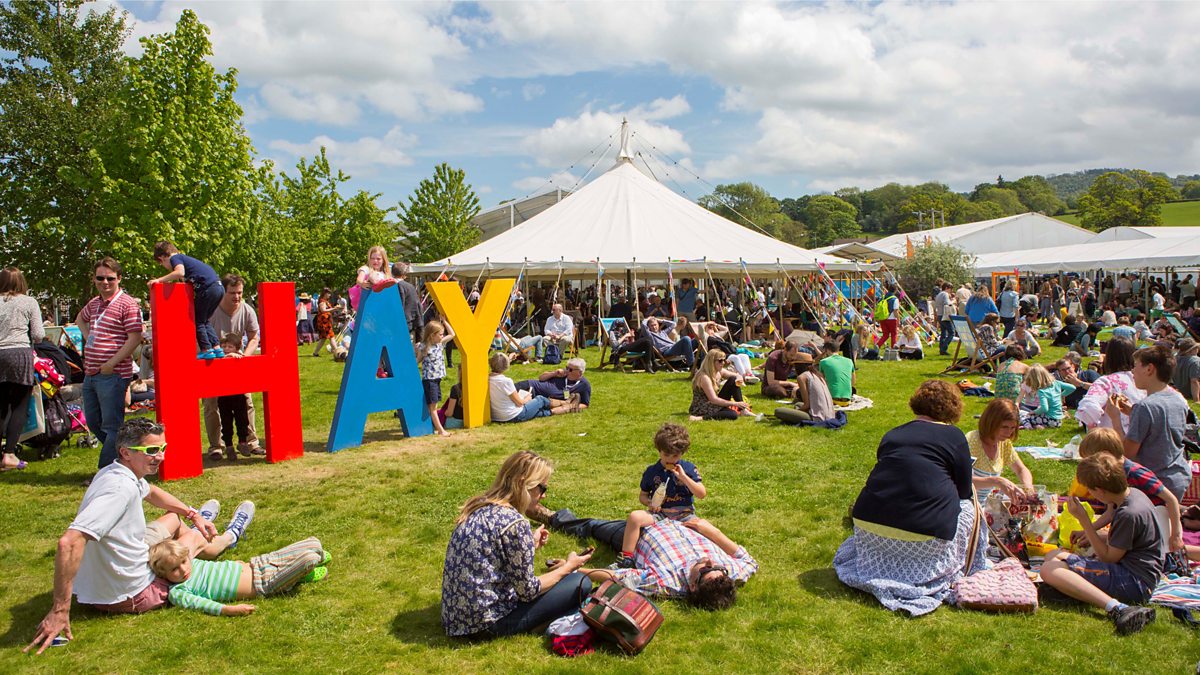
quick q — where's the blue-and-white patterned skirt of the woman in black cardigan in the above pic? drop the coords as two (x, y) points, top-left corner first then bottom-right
(833, 500), (991, 616)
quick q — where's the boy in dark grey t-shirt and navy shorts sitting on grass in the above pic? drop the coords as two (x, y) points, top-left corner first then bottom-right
(1042, 453), (1165, 634)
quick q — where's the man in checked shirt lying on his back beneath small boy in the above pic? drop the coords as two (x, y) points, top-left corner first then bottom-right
(529, 504), (758, 610)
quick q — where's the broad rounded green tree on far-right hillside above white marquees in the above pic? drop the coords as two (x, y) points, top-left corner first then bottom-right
(1079, 169), (1178, 231)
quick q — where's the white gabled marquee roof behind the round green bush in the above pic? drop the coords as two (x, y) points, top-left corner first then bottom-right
(870, 213), (1096, 258)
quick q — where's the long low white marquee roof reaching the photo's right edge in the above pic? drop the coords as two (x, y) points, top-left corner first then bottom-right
(974, 230), (1200, 276)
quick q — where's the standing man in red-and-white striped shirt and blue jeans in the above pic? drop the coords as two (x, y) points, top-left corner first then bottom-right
(76, 257), (142, 468)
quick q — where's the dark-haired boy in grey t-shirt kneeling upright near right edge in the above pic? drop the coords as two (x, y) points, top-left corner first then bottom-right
(1105, 345), (1192, 500)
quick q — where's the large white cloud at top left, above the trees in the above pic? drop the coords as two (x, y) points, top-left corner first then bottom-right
(119, 0), (482, 125)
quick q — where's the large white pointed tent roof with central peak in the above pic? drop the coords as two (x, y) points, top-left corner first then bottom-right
(414, 130), (878, 282)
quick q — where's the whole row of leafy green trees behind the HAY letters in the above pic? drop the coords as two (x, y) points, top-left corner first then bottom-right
(0, 0), (479, 299)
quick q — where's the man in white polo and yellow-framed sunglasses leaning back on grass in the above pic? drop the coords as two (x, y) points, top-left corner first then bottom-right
(25, 418), (254, 653)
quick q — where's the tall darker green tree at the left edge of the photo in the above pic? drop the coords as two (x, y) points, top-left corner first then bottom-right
(0, 0), (128, 299)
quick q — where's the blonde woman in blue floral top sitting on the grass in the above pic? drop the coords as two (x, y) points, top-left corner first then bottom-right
(442, 450), (592, 637)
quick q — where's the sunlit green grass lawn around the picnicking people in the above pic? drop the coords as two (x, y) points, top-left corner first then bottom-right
(0, 350), (1200, 674)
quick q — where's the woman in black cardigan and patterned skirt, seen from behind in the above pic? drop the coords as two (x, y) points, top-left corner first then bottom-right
(833, 380), (989, 616)
